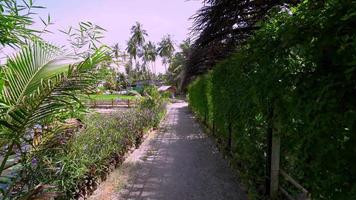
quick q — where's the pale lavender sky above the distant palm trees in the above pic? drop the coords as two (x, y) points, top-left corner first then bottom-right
(35, 0), (202, 72)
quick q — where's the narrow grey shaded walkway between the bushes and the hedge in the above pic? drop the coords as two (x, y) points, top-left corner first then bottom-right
(90, 103), (247, 200)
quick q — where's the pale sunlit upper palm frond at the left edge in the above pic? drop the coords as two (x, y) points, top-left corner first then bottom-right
(2, 42), (69, 105)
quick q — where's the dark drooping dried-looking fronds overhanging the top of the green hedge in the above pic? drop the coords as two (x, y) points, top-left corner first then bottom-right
(183, 0), (300, 85)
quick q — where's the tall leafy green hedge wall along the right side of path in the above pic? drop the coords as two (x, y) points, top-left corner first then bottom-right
(188, 0), (356, 199)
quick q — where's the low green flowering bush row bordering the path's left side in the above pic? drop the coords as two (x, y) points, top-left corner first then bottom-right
(18, 93), (168, 199)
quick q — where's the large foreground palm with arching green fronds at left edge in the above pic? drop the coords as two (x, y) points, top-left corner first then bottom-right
(0, 41), (108, 196)
